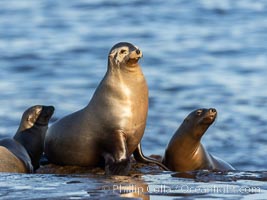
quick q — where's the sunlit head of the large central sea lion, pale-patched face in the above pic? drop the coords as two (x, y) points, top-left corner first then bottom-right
(109, 42), (143, 68)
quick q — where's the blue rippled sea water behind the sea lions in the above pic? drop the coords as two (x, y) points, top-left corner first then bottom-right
(0, 0), (267, 199)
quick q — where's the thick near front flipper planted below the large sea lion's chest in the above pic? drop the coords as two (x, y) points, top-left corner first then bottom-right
(102, 131), (130, 175)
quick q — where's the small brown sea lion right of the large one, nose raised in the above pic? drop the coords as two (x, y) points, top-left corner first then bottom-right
(162, 108), (234, 172)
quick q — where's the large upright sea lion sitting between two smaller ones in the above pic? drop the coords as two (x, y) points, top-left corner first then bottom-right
(45, 42), (168, 175)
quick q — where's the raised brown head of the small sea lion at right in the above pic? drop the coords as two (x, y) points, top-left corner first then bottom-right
(182, 108), (217, 139)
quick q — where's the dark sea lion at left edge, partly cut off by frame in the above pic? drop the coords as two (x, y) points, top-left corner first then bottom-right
(0, 105), (54, 173)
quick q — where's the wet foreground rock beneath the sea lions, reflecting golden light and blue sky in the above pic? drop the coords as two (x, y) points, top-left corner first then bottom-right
(0, 161), (267, 199)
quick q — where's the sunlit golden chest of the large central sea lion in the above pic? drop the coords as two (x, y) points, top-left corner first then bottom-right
(89, 72), (148, 152)
